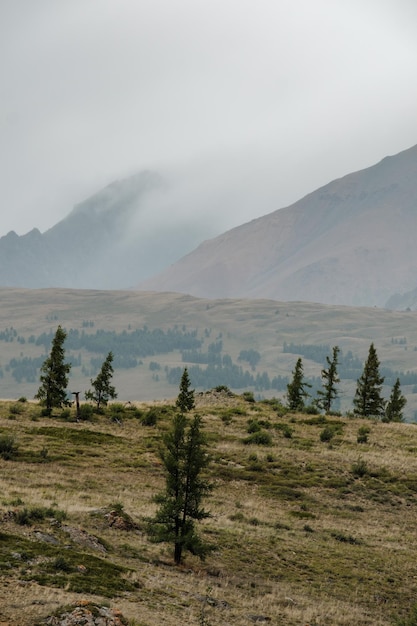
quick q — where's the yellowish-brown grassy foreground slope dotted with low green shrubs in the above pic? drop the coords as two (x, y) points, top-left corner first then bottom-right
(0, 392), (417, 626)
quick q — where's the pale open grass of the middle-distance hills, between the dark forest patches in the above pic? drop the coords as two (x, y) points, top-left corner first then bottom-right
(0, 289), (417, 421)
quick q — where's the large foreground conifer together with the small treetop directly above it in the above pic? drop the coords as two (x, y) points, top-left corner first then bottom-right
(148, 370), (212, 565)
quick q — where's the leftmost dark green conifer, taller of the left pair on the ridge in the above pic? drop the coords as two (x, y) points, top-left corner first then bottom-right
(35, 326), (71, 414)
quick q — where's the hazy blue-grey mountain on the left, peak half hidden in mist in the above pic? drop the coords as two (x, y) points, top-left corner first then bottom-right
(0, 171), (204, 289)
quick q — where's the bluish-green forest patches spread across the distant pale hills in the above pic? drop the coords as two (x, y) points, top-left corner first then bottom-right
(0, 321), (417, 392)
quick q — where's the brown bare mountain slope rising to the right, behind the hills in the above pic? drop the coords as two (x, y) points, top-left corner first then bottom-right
(139, 146), (417, 306)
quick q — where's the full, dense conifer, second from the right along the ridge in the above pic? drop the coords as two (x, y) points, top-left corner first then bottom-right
(353, 343), (385, 417)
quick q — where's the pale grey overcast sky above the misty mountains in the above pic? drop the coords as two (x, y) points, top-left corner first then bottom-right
(0, 0), (417, 235)
